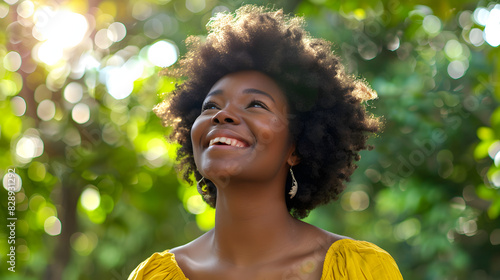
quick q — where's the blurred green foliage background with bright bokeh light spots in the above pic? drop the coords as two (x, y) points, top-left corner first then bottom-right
(0, 0), (500, 280)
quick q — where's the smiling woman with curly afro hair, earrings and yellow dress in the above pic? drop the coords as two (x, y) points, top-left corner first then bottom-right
(129, 6), (402, 280)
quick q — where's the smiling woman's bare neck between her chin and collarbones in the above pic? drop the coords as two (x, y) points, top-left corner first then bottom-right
(212, 180), (301, 265)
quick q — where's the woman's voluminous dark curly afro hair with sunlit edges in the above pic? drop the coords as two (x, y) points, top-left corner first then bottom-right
(155, 5), (380, 218)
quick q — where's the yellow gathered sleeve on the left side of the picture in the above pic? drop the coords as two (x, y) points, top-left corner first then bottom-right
(128, 250), (188, 280)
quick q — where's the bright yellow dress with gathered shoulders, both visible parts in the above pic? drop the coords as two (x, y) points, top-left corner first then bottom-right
(128, 239), (403, 280)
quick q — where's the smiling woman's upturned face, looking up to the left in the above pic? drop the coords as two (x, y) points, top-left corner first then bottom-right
(191, 71), (294, 187)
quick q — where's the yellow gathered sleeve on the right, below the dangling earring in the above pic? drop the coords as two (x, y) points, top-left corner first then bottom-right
(321, 239), (403, 280)
